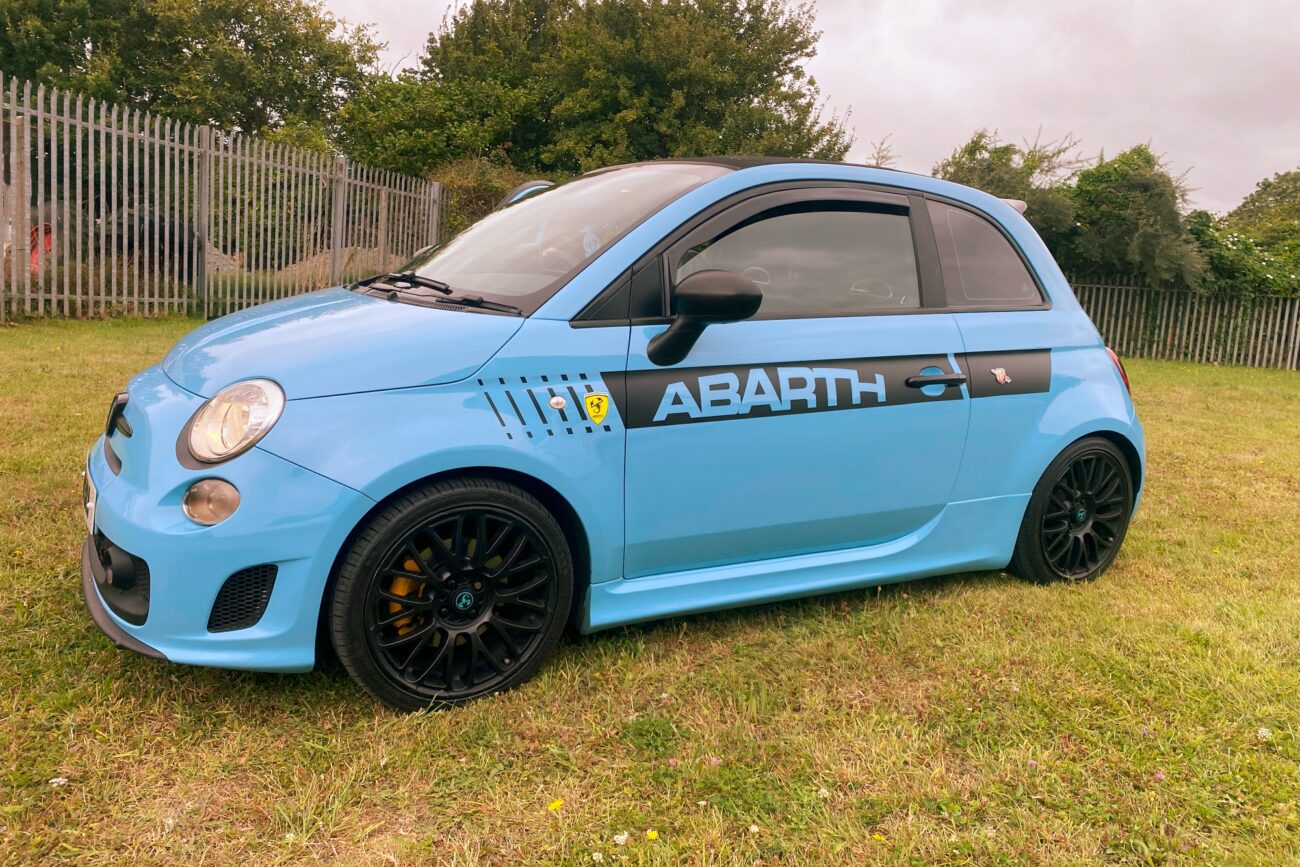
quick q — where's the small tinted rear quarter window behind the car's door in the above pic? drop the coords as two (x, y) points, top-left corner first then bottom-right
(927, 201), (1043, 307)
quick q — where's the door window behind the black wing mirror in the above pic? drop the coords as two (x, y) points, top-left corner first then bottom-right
(673, 203), (920, 316)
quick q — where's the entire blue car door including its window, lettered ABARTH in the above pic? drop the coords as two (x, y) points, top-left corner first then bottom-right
(616, 187), (969, 578)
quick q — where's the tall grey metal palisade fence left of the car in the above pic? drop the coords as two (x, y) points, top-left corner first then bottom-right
(0, 74), (442, 321)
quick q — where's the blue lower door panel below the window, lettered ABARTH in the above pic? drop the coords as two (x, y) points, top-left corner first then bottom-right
(625, 313), (970, 578)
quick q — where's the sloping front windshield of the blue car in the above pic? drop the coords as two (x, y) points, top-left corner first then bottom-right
(403, 162), (729, 312)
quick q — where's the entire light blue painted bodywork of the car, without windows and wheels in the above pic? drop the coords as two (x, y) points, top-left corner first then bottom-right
(76, 162), (1144, 671)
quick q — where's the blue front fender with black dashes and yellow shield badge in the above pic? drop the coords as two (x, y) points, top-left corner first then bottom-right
(260, 318), (628, 590)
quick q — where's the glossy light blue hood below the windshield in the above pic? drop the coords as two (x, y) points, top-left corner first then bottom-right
(163, 289), (524, 400)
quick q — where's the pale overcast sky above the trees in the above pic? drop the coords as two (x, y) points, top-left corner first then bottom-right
(326, 0), (1300, 211)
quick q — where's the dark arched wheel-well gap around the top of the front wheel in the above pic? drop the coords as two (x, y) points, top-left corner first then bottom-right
(316, 465), (592, 664)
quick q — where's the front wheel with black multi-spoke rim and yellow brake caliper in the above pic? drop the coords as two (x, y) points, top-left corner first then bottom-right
(330, 478), (573, 711)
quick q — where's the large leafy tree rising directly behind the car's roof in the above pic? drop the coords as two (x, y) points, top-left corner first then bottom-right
(343, 0), (852, 174)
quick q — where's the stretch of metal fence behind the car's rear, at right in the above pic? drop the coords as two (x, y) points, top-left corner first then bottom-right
(1074, 282), (1300, 370)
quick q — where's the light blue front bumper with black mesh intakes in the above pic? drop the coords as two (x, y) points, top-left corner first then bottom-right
(82, 368), (374, 672)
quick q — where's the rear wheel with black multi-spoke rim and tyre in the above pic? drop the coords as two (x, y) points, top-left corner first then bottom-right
(1009, 437), (1134, 584)
